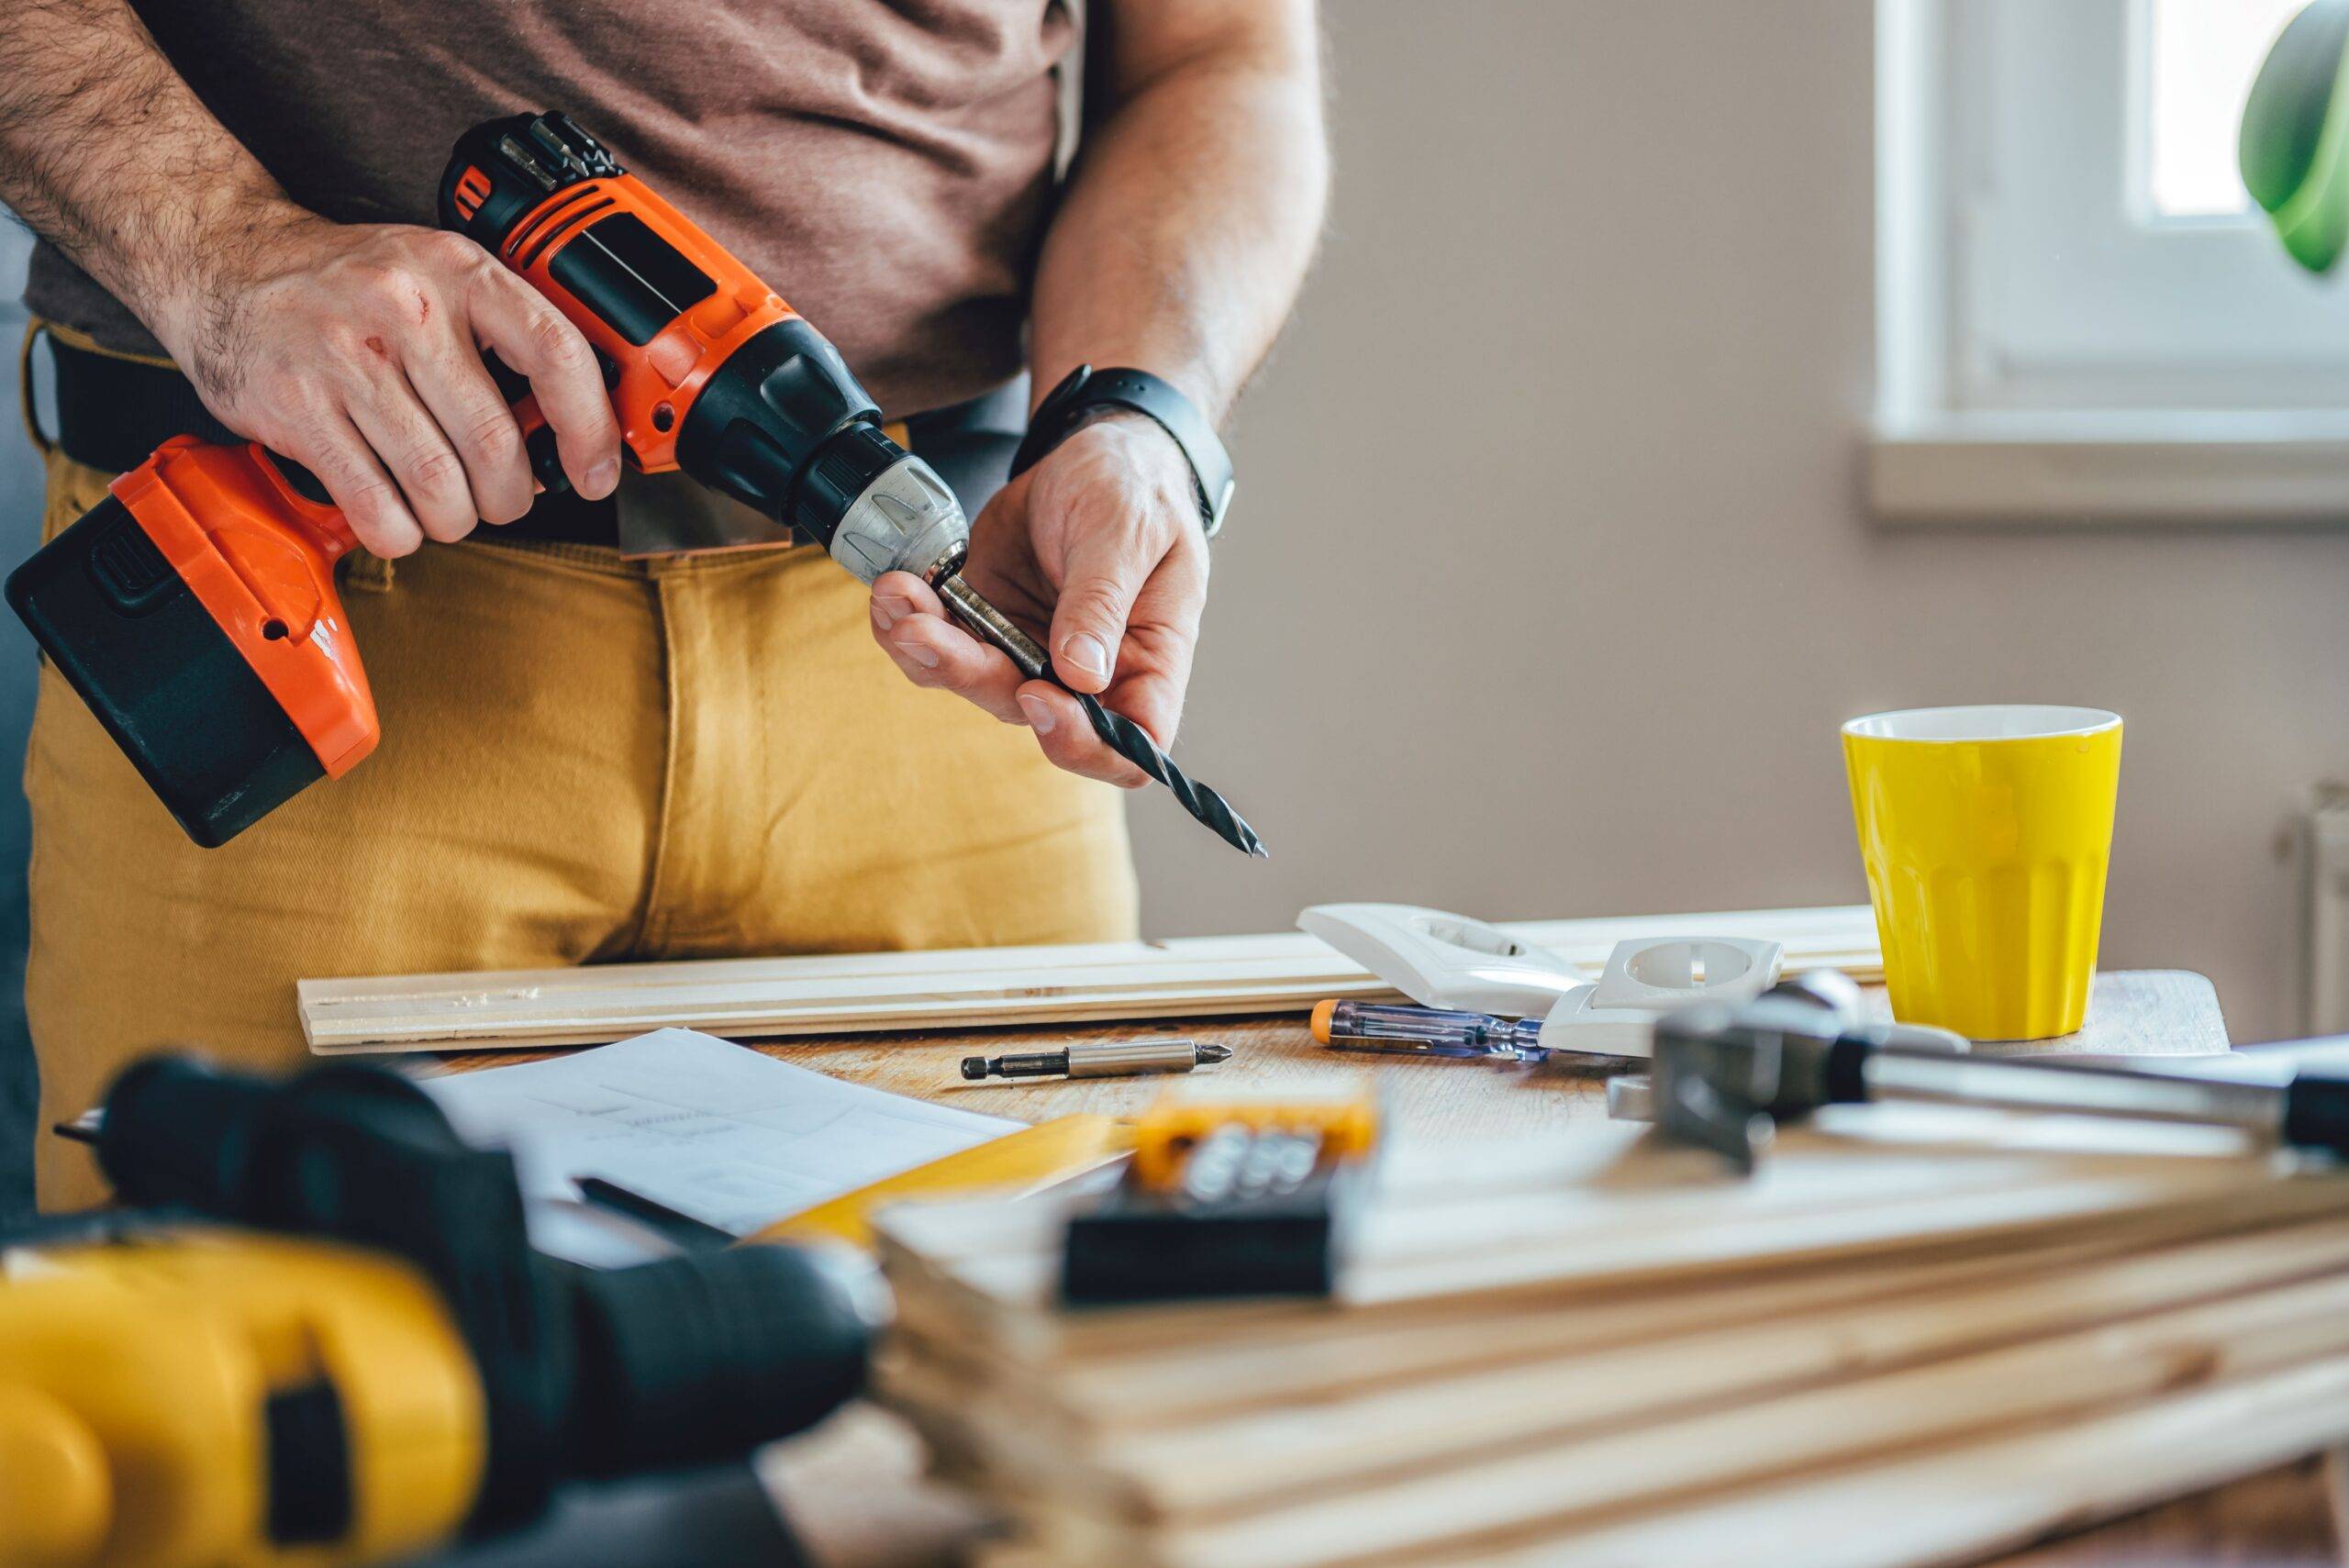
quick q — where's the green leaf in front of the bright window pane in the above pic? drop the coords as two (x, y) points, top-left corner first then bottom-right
(2236, 0), (2349, 272)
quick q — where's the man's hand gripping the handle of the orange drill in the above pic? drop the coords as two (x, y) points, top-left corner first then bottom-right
(150, 206), (620, 556)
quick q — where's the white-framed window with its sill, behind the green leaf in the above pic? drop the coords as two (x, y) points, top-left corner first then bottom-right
(1870, 0), (2349, 521)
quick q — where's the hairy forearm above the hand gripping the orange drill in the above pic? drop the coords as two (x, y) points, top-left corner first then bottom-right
(0, 0), (294, 345)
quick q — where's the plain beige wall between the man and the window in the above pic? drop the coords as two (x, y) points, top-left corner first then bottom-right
(1132, 0), (2349, 1040)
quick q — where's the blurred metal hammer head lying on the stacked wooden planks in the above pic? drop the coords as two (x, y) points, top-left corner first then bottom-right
(1649, 976), (1854, 1173)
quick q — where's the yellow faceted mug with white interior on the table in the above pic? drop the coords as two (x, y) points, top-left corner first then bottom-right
(1844, 705), (2121, 1040)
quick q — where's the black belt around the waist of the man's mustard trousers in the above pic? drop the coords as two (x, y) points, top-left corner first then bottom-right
(35, 328), (1027, 547)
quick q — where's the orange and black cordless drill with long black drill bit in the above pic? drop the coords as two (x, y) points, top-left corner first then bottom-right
(7, 113), (1262, 854)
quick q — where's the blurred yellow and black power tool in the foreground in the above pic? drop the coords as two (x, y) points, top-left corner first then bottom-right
(0, 1059), (878, 1568)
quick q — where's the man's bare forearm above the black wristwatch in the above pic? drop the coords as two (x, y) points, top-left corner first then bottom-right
(1031, 0), (1330, 420)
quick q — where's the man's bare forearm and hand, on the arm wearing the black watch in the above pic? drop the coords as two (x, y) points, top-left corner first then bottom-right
(872, 0), (1330, 789)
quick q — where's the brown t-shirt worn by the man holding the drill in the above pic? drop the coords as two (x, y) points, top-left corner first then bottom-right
(29, 0), (1075, 416)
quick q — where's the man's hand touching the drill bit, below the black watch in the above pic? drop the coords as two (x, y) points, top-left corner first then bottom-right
(872, 413), (1208, 789)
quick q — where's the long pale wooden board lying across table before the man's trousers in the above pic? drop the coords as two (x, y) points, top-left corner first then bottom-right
(296, 904), (1884, 1056)
